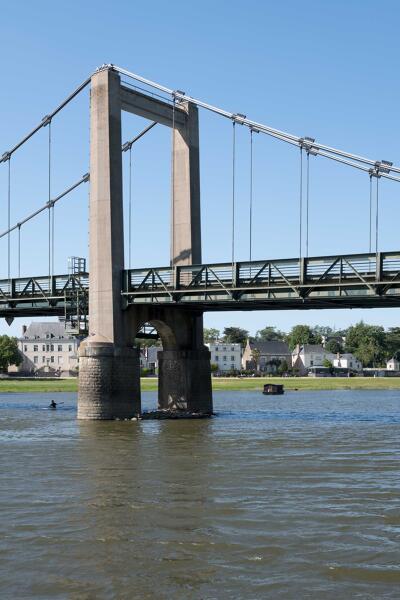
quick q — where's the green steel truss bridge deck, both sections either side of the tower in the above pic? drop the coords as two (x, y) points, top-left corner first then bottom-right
(0, 252), (400, 317)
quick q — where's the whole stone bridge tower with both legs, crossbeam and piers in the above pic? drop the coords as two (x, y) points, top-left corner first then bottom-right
(78, 67), (212, 419)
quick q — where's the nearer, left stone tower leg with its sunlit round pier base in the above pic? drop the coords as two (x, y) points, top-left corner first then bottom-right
(78, 69), (140, 419)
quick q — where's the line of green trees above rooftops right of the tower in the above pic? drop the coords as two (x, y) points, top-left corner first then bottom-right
(204, 321), (400, 367)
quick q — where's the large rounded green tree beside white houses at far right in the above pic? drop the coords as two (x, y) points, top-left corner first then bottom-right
(346, 321), (388, 367)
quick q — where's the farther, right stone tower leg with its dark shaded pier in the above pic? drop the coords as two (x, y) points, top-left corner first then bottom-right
(158, 103), (212, 414)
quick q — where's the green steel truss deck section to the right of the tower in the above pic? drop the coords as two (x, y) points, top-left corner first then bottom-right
(123, 252), (400, 311)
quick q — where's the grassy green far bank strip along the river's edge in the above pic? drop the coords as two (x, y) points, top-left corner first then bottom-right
(0, 377), (400, 394)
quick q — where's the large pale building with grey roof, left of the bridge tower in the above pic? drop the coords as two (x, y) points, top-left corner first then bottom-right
(9, 322), (79, 377)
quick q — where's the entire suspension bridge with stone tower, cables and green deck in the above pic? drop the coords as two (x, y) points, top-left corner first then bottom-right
(0, 65), (400, 419)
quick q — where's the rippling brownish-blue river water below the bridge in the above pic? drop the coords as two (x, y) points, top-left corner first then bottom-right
(0, 391), (400, 600)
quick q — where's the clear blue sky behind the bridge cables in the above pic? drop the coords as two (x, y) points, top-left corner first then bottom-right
(0, 0), (400, 334)
